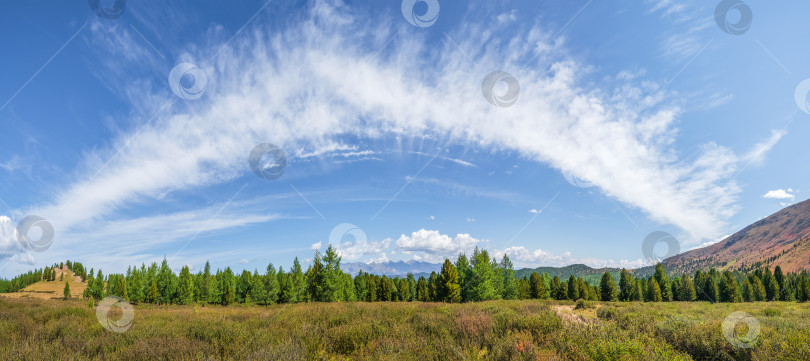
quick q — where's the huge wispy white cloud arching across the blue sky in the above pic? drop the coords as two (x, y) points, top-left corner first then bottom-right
(11, 1), (761, 262)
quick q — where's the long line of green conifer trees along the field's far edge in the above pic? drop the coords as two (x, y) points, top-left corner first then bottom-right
(4, 245), (810, 305)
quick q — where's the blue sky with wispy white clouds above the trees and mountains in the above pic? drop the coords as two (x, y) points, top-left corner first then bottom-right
(0, 0), (810, 278)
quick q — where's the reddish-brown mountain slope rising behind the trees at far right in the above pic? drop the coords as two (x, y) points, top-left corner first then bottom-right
(663, 200), (810, 273)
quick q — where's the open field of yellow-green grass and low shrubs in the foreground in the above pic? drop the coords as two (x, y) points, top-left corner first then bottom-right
(0, 297), (810, 360)
